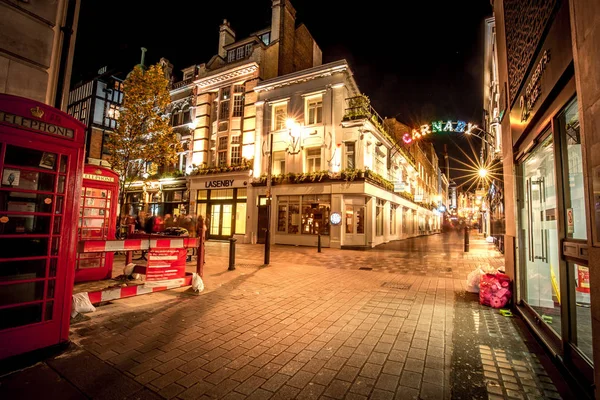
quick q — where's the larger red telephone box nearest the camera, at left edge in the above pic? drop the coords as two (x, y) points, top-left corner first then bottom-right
(0, 94), (85, 358)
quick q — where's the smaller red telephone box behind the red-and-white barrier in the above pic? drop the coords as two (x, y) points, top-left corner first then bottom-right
(75, 165), (119, 282)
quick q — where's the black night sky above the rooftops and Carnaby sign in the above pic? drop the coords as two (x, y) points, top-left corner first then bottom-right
(73, 0), (492, 184)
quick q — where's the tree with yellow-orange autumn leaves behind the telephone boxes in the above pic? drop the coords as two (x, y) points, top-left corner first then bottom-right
(106, 64), (183, 221)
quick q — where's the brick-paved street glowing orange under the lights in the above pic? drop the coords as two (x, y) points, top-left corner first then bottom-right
(0, 234), (573, 400)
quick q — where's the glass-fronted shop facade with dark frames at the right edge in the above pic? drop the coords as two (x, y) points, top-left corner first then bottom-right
(493, 0), (600, 398)
